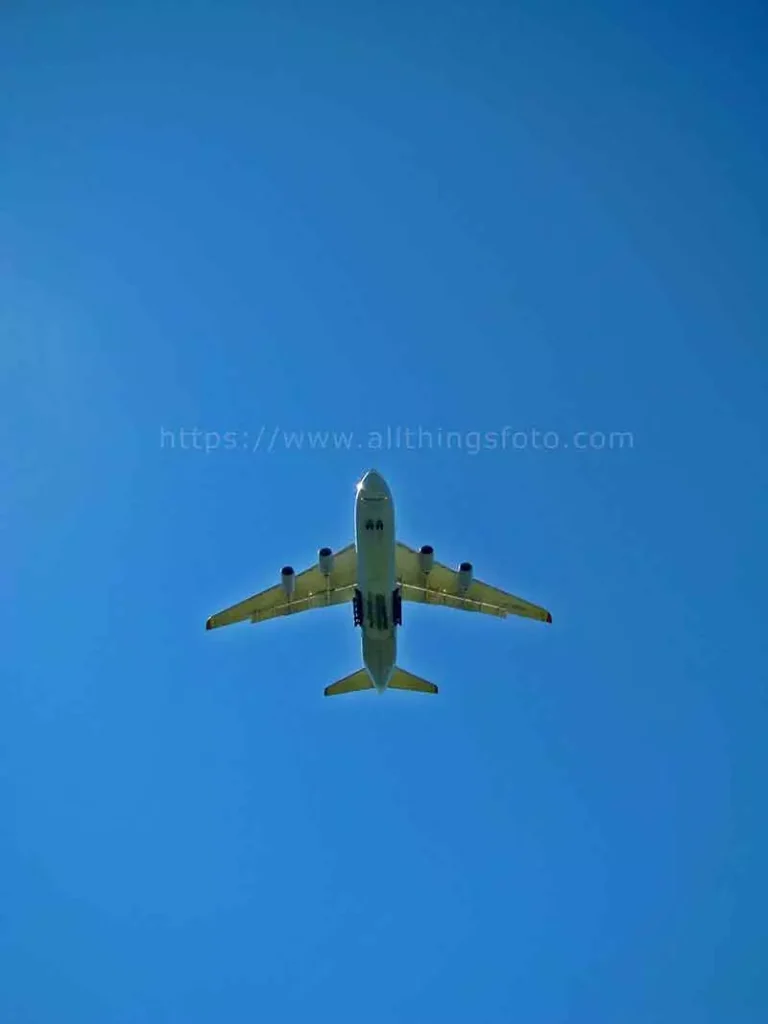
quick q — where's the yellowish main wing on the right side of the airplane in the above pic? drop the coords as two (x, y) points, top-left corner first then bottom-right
(395, 542), (552, 623)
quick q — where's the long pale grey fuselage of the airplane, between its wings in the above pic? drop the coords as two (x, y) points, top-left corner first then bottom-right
(354, 471), (399, 692)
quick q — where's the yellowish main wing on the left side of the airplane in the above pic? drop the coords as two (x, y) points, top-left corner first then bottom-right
(206, 544), (357, 630)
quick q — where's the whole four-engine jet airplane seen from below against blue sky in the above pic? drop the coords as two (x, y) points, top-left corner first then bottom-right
(206, 469), (552, 696)
